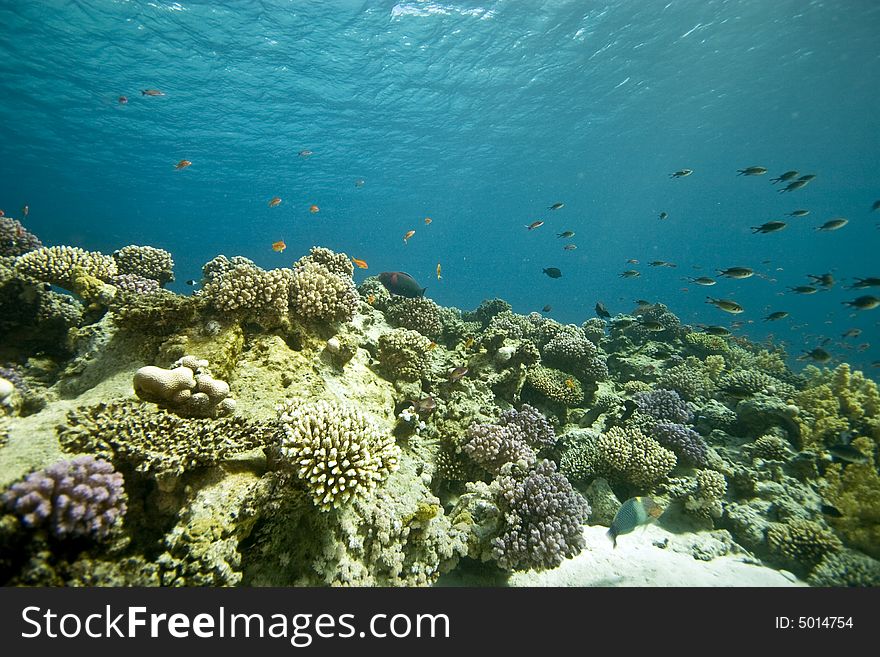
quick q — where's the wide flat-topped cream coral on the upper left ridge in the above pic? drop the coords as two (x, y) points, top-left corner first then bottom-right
(15, 246), (118, 290)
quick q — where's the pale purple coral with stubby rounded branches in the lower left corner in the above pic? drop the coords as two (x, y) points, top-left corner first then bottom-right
(2, 456), (126, 539)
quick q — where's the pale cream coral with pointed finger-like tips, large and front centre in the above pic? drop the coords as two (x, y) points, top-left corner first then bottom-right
(278, 401), (400, 511)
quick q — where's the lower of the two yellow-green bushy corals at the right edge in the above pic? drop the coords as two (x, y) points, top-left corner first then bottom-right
(824, 436), (880, 558)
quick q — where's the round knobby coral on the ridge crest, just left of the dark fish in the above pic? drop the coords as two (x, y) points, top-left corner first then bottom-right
(290, 258), (360, 322)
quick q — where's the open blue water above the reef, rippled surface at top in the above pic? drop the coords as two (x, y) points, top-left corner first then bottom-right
(0, 0), (880, 373)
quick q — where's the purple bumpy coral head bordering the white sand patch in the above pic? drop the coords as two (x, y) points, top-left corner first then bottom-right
(492, 460), (590, 570)
